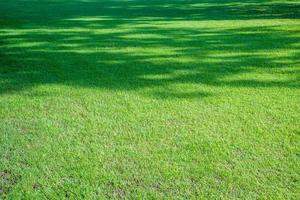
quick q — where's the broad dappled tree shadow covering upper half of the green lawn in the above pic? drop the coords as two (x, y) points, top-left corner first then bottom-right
(0, 1), (300, 98)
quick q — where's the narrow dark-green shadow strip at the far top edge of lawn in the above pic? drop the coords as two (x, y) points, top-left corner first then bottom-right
(0, 0), (300, 26)
